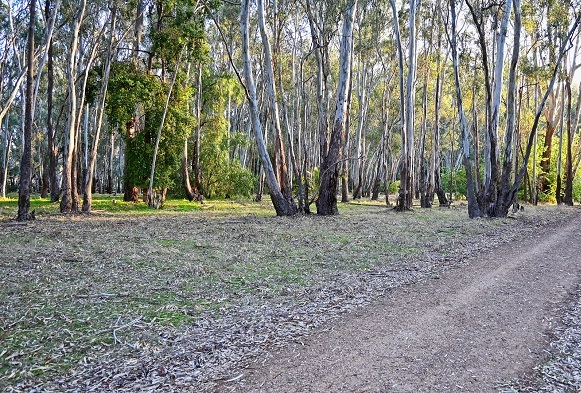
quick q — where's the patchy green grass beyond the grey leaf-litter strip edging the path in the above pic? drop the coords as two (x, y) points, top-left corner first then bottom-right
(0, 192), (572, 390)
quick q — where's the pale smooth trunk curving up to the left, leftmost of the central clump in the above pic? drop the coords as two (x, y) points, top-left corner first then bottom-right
(240, 0), (297, 216)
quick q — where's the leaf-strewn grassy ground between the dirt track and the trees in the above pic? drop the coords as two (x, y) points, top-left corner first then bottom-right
(0, 206), (579, 392)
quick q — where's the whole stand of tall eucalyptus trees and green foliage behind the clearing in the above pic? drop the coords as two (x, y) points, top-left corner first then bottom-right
(0, 0), (581, 219)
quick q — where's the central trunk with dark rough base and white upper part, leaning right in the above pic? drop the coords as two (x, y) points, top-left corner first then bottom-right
(316, 0), (357, 216)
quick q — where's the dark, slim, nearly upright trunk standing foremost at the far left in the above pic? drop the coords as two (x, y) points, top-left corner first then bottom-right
(17, 0), (36, 221)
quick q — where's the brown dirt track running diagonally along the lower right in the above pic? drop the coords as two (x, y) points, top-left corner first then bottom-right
(220, 216), (581, 392)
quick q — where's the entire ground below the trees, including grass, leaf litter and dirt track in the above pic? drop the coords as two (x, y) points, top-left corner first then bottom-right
(0, 202), (581, 392)
